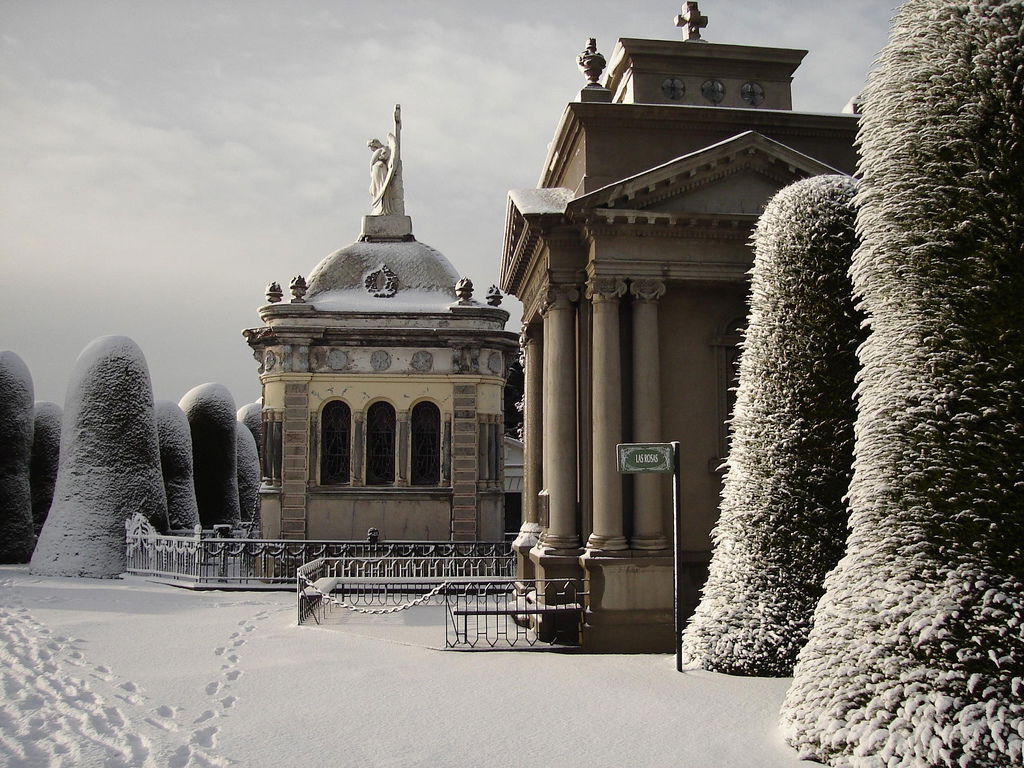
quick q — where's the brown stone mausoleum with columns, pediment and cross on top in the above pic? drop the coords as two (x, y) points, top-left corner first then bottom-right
(502, 7), (857, 651)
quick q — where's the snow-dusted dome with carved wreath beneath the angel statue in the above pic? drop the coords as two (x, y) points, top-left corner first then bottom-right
(305, 240), (459, 312)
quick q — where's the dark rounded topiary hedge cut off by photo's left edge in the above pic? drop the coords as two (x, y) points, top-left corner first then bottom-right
(0, 349), (36, 563)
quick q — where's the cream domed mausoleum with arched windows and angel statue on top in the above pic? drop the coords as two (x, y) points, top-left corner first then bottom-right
(244, 108), (518, 541)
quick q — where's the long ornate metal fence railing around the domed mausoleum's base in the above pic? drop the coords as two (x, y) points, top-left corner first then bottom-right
(127, 516), (515, 589)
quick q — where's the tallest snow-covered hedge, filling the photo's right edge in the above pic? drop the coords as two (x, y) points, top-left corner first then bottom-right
(782, 0), (1024, 767)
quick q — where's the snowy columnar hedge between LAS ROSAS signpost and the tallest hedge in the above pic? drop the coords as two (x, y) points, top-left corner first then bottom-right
(683, 176), (863, 676)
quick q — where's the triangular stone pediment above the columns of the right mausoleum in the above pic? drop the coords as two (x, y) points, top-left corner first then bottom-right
(566, 131), (845, 214)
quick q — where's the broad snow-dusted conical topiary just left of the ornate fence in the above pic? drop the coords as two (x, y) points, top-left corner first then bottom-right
(32, 336), (167, 578)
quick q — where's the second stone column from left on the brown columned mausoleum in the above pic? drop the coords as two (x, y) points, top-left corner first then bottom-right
(538, 286), (580, 550)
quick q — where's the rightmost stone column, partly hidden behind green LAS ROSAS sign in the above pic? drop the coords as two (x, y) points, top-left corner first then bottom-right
(630, 280), (669, 550)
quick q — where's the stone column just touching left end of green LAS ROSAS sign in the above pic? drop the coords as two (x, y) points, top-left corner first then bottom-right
(587, 278), (627, 551)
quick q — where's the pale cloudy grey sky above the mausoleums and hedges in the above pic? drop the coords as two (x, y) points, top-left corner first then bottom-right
(0, 0), (897, 406)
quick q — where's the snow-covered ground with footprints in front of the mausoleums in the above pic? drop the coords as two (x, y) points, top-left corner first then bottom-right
(0, 566), (811, 768)
